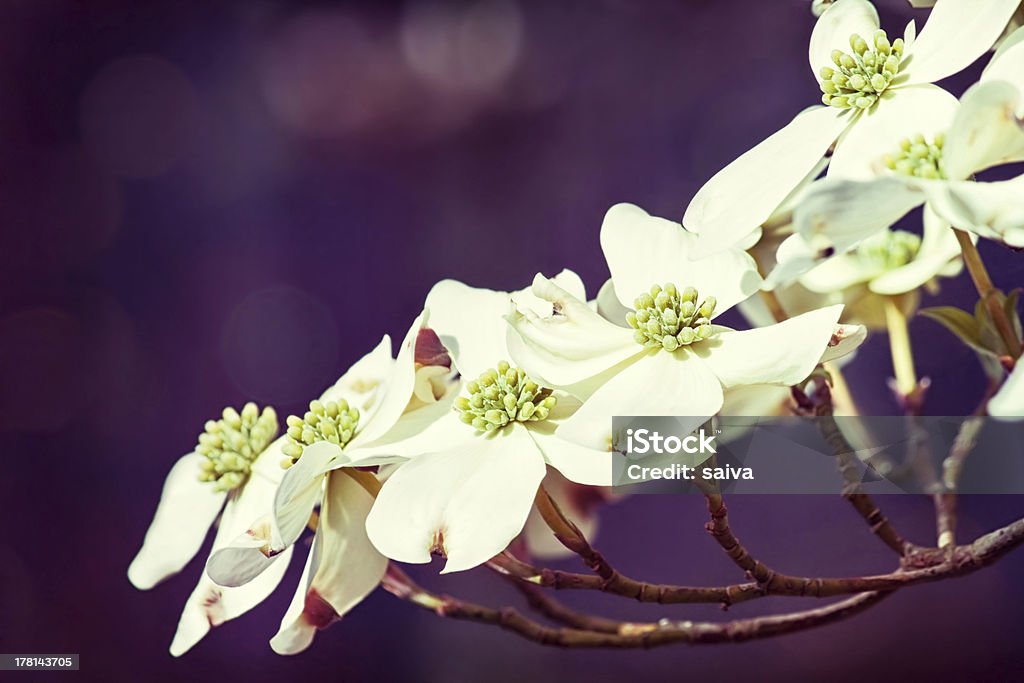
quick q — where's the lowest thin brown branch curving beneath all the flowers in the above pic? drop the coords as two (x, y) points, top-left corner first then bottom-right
(383, 565), (888, 648)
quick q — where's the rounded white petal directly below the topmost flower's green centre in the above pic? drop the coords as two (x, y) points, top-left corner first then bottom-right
(827, 85), (959, 180)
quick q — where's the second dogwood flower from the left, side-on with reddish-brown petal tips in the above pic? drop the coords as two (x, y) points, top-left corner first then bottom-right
(201, 311), (451, 654)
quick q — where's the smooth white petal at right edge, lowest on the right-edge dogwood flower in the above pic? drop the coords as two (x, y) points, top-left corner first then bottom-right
(926, 175), (1024, 247)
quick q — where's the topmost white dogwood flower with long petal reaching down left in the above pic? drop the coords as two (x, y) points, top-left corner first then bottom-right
(683, 0), (1017, 249)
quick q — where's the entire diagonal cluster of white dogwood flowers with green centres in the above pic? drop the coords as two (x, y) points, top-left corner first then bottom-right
(129, 0), (1024, 654)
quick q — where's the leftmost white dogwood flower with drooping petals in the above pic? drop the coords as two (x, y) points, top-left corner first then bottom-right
(128, 403), (290, 656)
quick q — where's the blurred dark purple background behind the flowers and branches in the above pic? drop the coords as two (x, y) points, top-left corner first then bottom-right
(0, 0), (1024, 683)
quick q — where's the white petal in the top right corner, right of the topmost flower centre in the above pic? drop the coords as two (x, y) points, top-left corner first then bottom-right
(903, 0), (1020, 83)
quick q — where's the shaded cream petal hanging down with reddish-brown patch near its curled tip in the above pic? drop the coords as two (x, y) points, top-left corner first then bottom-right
(270, 471), (387, 654)
